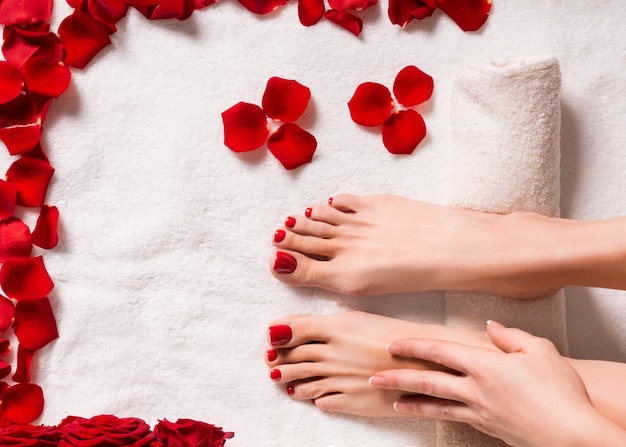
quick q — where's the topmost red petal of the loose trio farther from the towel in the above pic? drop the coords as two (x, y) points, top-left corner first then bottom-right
(261, 77), (311, 123)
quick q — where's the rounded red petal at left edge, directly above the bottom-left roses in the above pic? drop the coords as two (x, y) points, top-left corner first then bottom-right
(1, 383), (44, 424)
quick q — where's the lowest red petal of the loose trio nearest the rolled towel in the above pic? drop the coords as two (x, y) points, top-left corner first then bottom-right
(383, 109), (426, 154)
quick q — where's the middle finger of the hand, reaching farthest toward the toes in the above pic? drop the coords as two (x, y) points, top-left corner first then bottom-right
(370, 369), (471, 403)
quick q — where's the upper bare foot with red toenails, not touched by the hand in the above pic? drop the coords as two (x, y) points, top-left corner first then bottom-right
(270, 194), (562, 298)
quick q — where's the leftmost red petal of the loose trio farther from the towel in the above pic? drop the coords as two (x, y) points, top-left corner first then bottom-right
(222, 102), (269, 152)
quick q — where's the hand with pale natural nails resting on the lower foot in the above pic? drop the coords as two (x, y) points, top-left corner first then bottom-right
(370, 322), (626, 447)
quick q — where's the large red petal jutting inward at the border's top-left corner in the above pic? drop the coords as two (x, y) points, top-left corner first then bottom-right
(59, 10), (111, 68)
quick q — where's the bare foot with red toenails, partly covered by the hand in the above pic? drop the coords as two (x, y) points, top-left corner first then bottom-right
(266, 312), (495, 417)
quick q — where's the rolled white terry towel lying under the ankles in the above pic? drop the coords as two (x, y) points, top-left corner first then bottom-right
(438, 57), (567, 447)
